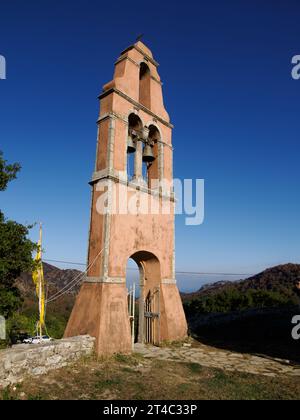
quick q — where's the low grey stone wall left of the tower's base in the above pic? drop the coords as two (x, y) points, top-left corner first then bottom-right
(0, 335), (95, 387)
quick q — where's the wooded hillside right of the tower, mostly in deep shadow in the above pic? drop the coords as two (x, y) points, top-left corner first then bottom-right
(183, 264), (300, 363)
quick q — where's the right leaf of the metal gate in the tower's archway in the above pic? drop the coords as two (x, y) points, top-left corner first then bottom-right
(144, 287), (160, 345)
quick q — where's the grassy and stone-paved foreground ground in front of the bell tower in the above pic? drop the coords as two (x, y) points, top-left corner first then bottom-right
(0, 341), (300, 400)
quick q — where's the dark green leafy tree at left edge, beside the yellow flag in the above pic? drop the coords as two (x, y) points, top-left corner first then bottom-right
(0, 151), (36, 317)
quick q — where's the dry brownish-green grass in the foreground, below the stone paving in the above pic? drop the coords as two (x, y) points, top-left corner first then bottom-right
(0, 354), (300, 400)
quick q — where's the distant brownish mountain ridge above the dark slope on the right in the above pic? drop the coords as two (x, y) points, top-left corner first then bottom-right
(182, 264), (300, 301)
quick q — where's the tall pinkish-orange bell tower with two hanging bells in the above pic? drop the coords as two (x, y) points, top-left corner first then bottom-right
(65, 41), (187, 354)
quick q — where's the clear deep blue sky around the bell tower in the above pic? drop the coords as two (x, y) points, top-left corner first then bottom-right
(0, 0), (300, 288)
